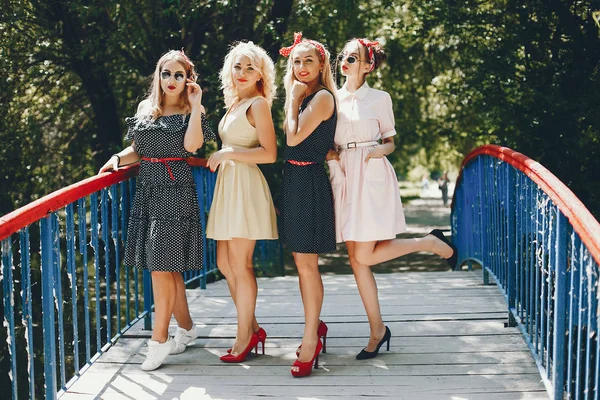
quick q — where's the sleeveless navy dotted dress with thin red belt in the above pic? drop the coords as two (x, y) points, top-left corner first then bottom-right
(279, 89), (337, 254)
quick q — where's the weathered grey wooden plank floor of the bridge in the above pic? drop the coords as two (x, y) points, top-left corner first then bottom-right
(62, 272), (548, 400)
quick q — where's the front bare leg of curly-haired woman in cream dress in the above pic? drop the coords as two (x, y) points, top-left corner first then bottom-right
(228, 238), (258, 355)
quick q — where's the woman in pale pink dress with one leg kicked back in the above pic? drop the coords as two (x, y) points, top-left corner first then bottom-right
(327, 39), (457, 360)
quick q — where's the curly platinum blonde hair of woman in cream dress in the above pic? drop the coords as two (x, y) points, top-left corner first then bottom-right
(219, 42), (277, 108)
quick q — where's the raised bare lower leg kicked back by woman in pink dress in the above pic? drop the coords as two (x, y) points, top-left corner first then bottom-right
(355, 235), (452, 265)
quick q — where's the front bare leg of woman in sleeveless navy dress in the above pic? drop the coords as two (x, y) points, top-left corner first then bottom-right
(292, 253), (323, 369)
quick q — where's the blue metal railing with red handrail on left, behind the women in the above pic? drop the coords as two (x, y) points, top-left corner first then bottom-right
(0, 162), (283, 399)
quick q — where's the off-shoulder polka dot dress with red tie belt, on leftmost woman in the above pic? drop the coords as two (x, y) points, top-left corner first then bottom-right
(124, 114), (214, 272)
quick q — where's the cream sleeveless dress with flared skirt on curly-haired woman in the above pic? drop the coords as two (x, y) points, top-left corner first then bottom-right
(206, 96), (278, 240)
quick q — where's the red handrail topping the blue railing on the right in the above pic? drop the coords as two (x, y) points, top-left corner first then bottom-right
(457, 144), (600, 264)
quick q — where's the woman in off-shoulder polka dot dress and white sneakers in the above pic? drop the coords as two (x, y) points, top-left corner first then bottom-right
(100, 50), (214, 371)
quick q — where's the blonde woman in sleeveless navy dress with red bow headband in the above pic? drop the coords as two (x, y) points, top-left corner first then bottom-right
(280, 33), (337, 376)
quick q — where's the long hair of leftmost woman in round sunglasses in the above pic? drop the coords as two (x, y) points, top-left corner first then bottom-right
(147, 50), (198, 119)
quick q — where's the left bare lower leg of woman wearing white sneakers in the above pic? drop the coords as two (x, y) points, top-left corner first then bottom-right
(151, 271), (177, 343)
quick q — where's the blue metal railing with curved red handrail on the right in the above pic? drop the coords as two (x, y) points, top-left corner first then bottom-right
(452, 145), (600, 399)
